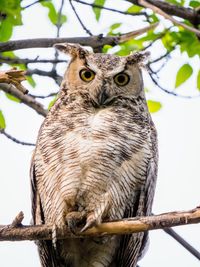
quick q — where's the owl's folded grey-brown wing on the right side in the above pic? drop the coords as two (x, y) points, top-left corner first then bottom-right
(116, 151), (157, 267)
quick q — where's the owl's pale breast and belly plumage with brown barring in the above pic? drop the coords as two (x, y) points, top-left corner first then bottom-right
(34, 96), (155, 267)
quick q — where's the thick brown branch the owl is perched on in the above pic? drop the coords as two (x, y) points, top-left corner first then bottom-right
(0, 208), (200, 241)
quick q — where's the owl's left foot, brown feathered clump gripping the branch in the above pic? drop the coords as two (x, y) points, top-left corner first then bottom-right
(65, 211), (86, 234)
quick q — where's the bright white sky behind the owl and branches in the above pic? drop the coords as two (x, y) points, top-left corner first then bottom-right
(0, 1), (200, 267)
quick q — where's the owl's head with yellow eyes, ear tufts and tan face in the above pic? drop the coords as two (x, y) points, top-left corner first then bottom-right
(54, 43), (147, 106)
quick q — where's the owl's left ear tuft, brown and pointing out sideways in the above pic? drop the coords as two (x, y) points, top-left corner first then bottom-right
(53, 43), (89, 58)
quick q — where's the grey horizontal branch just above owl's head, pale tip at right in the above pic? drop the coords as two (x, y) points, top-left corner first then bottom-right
(0, 24), (157, 52)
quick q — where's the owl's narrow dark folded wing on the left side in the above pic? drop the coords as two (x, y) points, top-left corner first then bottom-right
(31, 161), (63, 267)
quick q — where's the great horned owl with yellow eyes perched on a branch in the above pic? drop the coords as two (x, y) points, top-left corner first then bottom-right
(31, 44), (157, 267)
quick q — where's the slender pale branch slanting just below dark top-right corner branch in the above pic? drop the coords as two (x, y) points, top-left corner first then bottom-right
(138, 0), (200, 37)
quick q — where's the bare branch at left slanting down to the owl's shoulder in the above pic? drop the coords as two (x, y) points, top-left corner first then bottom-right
(0, 83), (48, 117)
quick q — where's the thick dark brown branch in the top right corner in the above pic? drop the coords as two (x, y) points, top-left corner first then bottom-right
(126, 0), (200, 25)
